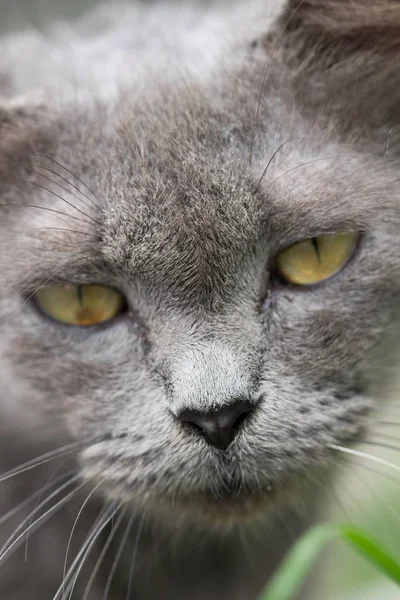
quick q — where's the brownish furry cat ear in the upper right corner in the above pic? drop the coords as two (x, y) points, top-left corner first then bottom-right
(277, 0), (400, 127)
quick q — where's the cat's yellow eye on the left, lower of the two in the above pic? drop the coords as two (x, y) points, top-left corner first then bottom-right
(33, 283), (125, 327)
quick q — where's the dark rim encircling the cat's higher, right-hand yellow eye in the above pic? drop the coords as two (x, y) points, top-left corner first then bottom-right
(270, 230), (365, 292)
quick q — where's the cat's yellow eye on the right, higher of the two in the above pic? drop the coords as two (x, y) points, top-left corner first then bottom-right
(277, 233), (358, 285)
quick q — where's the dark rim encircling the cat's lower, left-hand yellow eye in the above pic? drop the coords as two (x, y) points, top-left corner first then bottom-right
(29, 279), (131, 332)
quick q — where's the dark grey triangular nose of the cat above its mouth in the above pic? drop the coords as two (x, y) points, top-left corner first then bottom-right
(178, 400), (254, 450)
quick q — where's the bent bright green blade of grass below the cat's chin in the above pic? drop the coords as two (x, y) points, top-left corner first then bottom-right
(260, 524), (400, 600)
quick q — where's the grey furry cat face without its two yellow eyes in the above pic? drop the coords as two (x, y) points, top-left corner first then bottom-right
(0, 0), (400, 522)
